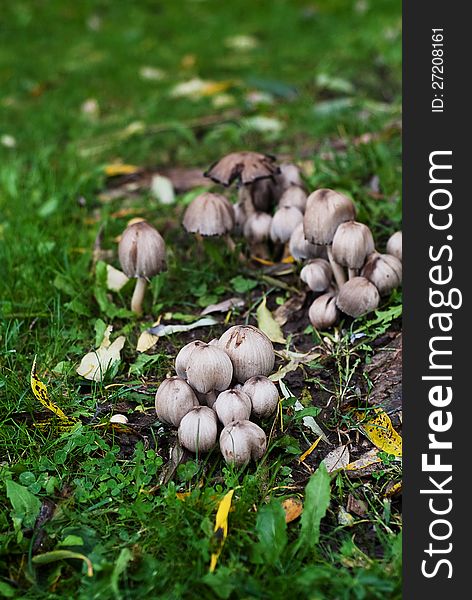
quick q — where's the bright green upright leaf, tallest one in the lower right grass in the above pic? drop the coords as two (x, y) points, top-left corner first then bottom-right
(296, 463), (331, 551)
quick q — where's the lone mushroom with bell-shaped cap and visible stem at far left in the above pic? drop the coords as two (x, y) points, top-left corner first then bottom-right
(118, 221), (166, 315)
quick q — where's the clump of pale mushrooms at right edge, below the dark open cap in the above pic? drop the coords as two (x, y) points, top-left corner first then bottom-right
(302, 189), (402, 329)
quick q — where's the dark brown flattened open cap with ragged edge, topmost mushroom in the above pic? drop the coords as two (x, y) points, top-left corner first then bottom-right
(204, 152), (279, 186)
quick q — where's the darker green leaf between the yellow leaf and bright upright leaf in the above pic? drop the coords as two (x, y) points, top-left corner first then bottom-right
(254, 500), (287, 565)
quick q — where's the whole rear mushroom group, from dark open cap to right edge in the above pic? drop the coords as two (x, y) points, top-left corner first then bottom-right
(191, 152), (402, 329)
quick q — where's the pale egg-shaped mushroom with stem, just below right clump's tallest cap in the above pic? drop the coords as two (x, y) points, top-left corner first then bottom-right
(333, 221), (375, 279)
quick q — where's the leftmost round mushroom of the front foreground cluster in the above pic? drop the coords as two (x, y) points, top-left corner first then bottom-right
(155, 377), (198, 427)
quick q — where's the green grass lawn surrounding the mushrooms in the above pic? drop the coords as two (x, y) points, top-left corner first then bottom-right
(0, 0), (401, 600)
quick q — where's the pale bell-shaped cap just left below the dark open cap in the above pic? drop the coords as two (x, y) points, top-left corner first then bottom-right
(182, 192), (234, 236)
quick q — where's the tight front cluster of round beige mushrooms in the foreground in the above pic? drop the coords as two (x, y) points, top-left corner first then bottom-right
(155, 325), (279, 466)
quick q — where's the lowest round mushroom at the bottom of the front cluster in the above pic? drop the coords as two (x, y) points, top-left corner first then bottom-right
(220, 421), (267, 467)
